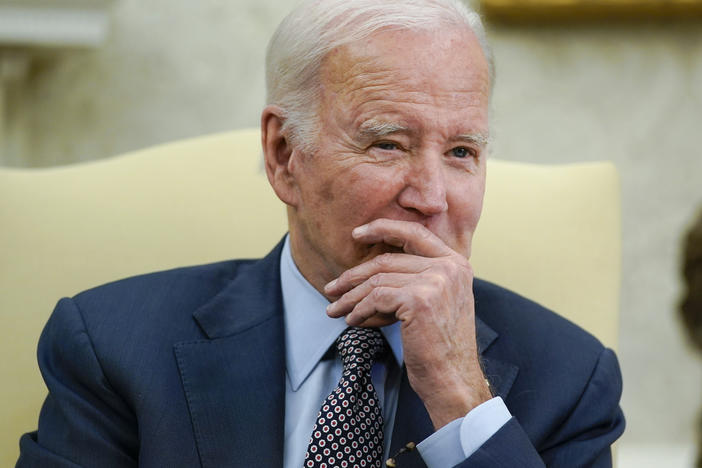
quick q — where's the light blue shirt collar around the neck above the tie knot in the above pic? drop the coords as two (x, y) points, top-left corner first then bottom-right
(280, 236), (402, 391)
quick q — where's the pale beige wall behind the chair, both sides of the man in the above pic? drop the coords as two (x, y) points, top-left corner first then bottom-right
(0, 0), (702, 452)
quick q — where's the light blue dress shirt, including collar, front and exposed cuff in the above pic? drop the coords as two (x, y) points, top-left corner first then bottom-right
(280, 237), (511, 468)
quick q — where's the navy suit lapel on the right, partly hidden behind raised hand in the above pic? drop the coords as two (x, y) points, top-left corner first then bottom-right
(390, 317), (518, 468)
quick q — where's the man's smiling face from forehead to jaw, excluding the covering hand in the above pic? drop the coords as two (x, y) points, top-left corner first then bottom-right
(289, 28), (489, 289)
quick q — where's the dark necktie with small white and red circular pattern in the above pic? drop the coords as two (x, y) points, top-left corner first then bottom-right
(304, 327), (385, 468)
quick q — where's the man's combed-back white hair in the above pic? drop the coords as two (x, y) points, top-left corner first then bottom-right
(266, 0), (494, 153)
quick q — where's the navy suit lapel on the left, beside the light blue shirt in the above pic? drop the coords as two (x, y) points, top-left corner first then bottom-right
(174, 245), (285, 468)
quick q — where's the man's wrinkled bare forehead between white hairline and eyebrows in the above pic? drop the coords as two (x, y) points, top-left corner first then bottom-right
(320, 27), (489, 133)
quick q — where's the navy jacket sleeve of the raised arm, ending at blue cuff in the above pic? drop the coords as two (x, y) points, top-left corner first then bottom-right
(457, 349), (625, 468)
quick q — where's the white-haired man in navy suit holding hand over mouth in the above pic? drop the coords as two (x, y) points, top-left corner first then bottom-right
(18, 0), (624, 467)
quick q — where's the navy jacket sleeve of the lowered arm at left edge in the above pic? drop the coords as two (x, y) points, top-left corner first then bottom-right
(17, 299), (138, 468)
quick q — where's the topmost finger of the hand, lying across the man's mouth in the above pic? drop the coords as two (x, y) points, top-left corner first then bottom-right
(351, 218), (454, 257)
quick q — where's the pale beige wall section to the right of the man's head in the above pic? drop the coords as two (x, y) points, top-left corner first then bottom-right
(493, 25), (702, 443)
